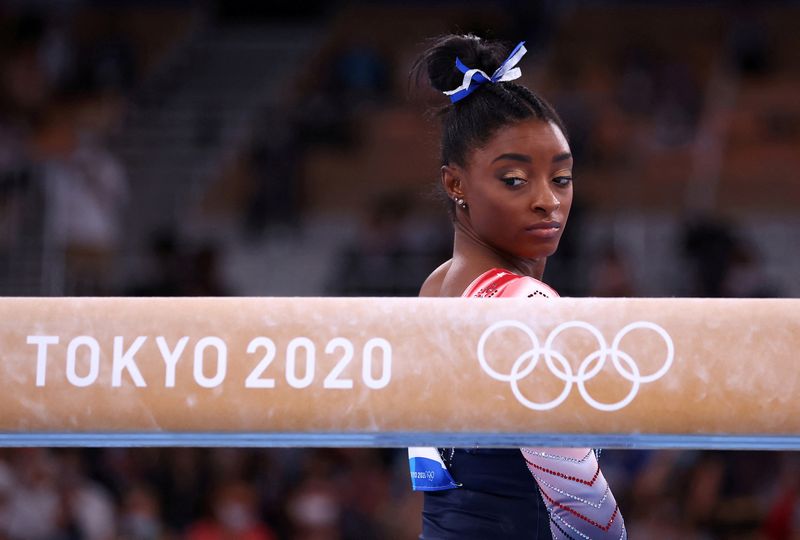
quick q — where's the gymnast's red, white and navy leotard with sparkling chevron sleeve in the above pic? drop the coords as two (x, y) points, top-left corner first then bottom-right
(409, 268), (626, 540)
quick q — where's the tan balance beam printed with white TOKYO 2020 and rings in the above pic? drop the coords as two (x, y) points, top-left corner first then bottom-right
(0, 298), (800, 449)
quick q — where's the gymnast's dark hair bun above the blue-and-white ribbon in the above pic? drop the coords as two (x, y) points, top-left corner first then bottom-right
(414, 34), (508, 92)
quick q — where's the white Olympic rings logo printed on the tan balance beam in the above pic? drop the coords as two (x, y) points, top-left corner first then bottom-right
(478, 320), (675, 411)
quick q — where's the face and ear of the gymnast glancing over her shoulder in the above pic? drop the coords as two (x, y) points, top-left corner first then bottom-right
(442, 118), (572, 259)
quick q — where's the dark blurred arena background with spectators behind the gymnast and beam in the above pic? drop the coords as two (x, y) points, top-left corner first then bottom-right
(0, 0), (800, 540)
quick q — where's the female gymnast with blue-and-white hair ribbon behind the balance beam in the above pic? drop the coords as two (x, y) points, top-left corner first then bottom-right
(409, 35), (626, 540)
